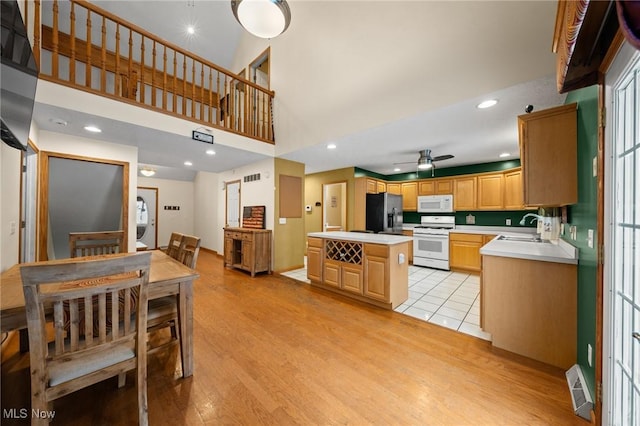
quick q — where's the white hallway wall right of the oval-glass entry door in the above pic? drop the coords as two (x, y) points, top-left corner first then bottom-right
(133, 176), (196, 247)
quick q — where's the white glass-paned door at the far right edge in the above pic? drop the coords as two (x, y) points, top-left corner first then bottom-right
(603, 45), (640, 425)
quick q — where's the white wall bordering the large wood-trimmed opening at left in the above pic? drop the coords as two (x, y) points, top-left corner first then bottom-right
(36, 131), (138, 251)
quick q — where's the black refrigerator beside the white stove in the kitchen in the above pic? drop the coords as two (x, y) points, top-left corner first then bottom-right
(367, 192), (402, 235)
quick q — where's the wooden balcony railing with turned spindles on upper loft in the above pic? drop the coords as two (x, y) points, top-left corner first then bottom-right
(25, 0), (274, 143)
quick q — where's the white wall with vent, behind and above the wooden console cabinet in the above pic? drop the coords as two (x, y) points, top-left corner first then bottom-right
(215, 159), (275, 254)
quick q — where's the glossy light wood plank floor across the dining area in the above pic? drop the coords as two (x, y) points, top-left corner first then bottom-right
(0, 252), (588, 426)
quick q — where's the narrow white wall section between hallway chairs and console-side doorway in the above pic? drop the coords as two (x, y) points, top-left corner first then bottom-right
(193, 172), (219, 255)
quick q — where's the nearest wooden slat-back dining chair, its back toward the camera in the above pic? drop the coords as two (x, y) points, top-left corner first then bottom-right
(20, 253), (151, 425)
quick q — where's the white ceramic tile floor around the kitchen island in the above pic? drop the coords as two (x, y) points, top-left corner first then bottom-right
(282, 259), (491, 340)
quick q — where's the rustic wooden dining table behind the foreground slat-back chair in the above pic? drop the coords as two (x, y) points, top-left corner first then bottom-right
(0, 250), (200, 377)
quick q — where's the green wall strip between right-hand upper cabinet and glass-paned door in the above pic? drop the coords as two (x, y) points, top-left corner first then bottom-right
(562, 86), (598, 396)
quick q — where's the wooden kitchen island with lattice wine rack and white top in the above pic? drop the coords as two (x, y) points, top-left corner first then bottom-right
(307, 232), (412, 309)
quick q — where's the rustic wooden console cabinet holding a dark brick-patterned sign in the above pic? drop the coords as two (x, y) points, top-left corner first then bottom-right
(224, 228), (271, 277)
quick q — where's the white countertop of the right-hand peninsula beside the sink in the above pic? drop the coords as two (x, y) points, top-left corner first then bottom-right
(480, 233), (578, 265)
